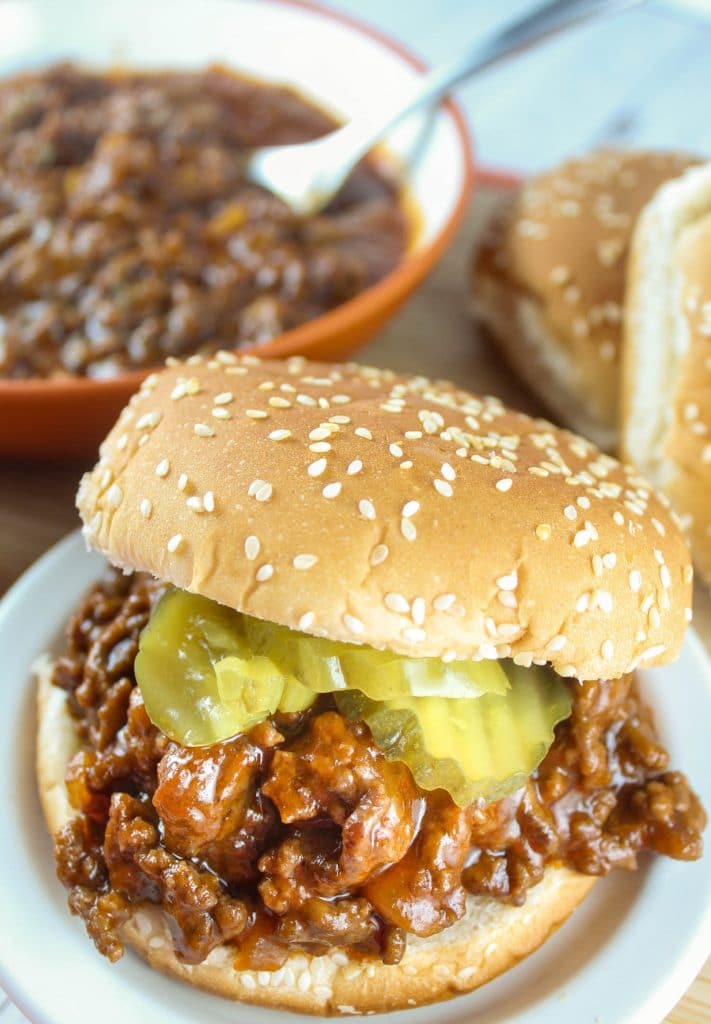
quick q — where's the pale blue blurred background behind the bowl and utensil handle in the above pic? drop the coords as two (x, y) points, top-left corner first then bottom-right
(330, 0), (711, 173)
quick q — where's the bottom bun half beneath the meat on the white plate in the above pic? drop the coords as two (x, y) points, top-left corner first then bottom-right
(37, 662), (595, 1014)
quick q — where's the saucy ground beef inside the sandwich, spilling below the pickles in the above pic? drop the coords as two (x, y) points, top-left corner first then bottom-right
(53, 572), (705, 970)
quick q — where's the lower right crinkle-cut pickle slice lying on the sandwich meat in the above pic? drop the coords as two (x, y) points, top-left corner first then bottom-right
(334, 663), (571, 807)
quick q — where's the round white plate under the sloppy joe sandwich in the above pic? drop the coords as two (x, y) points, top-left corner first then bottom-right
(0, 534), (711, 1024)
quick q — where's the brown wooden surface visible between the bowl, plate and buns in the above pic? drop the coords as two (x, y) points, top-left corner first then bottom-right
(0, 188), (711, 1024)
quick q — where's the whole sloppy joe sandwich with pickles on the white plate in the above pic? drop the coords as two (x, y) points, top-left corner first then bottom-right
(38, 353), (705, 1014)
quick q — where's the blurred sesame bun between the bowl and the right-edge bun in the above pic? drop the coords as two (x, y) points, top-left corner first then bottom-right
(471, 150), (694, 447)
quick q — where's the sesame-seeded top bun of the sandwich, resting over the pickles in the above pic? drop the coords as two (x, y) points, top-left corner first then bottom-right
(78, 352), (692, 679)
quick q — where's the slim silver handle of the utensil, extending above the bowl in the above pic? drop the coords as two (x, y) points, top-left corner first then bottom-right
(337, 0), (644, 156)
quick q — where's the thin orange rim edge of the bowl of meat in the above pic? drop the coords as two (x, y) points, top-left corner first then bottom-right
(0, 0), (475, 399)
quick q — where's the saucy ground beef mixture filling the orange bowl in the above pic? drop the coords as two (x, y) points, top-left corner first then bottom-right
(0, 65), (409, 378)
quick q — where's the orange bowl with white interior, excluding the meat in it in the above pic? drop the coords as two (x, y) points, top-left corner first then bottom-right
(0, 0), (473, 457)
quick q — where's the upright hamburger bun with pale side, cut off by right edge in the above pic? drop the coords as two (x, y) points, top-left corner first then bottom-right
(622, 164), (711, 584)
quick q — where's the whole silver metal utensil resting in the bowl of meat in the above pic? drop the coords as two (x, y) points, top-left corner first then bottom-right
(247, 0), (643, 216)
